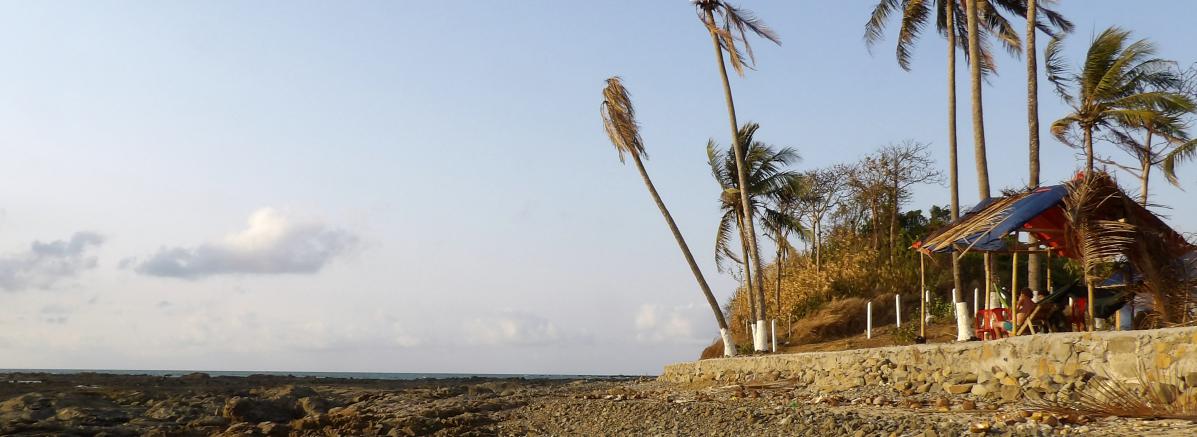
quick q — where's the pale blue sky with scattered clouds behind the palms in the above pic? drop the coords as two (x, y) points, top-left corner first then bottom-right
(0, 0), (1197, 374)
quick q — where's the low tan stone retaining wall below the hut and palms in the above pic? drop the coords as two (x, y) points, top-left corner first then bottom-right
(660, 327), (1197, 401)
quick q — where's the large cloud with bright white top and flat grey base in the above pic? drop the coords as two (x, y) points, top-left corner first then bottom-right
(134, 208), (358, 279)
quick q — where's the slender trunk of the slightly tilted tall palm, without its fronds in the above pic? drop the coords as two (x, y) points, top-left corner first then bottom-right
(706, 10), (768, 351)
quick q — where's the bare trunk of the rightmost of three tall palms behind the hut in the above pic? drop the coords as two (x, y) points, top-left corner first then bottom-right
(1027, 0), (1043, 294)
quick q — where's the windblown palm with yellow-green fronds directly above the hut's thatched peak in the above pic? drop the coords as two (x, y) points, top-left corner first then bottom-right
(1045, 28), (1192, 174)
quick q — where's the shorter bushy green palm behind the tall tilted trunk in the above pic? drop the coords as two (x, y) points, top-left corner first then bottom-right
(706, 123), (802, 329)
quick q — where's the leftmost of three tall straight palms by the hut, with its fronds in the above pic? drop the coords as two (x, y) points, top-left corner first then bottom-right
(864, 0), (1026, 301)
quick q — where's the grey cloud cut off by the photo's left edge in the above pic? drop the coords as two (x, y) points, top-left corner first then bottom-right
(0, 232), (104, 291)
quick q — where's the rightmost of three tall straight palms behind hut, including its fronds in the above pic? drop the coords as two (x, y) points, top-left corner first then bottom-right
(1025, 0), (1073, 290)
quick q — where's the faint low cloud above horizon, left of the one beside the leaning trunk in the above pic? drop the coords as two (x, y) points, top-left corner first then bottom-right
(464, 310), (585, 346)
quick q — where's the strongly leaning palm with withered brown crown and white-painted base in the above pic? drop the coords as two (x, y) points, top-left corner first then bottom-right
(600, 75), (736, 357)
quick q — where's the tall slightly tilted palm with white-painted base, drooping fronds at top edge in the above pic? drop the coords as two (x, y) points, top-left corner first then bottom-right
(694, 0), (782, 351)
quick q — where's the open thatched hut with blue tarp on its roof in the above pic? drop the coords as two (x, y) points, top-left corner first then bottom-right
(913, 172), (1197, 329)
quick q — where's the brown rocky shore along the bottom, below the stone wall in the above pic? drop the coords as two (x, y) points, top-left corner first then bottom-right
(0, 374), (1197, 436)
